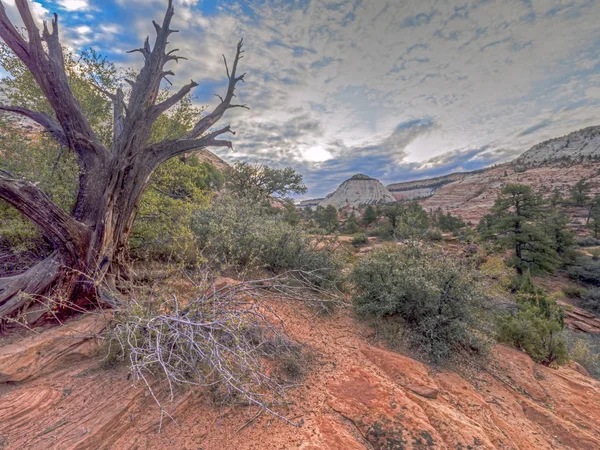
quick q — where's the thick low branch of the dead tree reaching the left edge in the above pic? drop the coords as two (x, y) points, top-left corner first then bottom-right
(0, 175), (91, 255)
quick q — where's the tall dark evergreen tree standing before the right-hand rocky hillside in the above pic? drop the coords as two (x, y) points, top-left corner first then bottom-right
(487, 184), (559, 276)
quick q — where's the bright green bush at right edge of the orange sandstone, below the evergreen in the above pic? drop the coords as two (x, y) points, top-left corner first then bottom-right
(498, 273), (569, 365)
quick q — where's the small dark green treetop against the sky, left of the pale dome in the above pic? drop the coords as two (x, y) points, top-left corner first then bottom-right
(226, 161), (307, 201)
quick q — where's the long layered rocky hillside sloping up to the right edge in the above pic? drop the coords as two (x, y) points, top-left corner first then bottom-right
(400, 126), (600, 224)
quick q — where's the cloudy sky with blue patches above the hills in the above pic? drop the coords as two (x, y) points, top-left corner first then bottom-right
(3, 0), (600, 198)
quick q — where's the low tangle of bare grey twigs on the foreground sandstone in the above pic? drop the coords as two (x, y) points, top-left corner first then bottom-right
(106, 277), (328, 426)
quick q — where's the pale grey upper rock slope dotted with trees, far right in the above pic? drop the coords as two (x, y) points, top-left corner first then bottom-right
(516, 126), (600, 165)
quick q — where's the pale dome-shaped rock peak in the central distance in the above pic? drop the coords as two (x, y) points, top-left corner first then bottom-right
(319, 174), (396, 209)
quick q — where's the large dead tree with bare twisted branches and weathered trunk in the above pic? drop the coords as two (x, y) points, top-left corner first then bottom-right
(0, 0), (245, 319)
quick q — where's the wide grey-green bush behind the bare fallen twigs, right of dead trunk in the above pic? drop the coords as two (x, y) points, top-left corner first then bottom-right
(192, 196), (342, 287)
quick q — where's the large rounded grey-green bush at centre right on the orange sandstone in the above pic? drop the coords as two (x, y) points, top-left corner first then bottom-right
(351, 246), (485, 362)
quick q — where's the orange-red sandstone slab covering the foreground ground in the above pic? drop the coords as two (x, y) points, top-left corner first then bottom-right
(0, 298), (600, 450)
